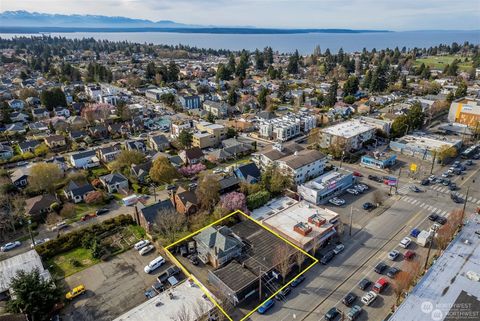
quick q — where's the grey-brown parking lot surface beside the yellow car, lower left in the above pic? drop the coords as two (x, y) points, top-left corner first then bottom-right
(62, 249), (171, 321)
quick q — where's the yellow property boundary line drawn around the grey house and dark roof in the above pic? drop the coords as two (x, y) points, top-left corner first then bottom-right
(165, 210), (318, 321)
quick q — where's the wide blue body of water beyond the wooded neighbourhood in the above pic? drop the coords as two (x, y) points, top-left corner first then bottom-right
(0, 30), (480, 54)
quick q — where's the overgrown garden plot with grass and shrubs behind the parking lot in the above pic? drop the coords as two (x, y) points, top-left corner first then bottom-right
(36, 215), (145, 279)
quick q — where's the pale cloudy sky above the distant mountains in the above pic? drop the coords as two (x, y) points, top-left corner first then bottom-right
(0, 0), (480, 31)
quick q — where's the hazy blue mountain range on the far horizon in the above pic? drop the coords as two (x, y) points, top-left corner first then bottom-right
(0, 10), (388, 34)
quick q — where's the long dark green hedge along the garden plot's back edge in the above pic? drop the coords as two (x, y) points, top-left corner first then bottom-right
(35, 214), (134, 259)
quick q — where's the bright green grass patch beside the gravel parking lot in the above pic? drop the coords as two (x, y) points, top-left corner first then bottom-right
(47, 247), (100, 278)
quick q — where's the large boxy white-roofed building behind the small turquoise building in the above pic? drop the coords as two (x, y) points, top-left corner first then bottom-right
(319, 119), (377, 150)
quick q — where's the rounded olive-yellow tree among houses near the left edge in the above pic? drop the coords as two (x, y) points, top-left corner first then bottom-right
(28, 163), (63, 193)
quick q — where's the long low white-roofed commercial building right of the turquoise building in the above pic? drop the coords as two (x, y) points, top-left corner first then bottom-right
(390, 133), (462, 161)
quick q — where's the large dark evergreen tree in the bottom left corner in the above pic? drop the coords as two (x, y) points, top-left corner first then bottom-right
(7, 269), (62, 321)
